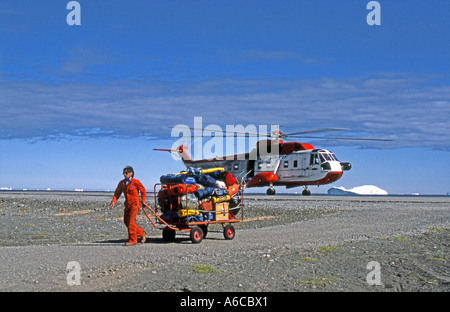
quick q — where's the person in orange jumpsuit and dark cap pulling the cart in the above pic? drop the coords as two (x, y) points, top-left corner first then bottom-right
(109, 166), (146, 246)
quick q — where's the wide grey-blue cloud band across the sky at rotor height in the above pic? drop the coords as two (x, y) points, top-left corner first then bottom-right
(0, 75), (450, 150)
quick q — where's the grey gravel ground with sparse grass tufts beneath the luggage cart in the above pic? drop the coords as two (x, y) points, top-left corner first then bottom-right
(0, 192), (450, 293)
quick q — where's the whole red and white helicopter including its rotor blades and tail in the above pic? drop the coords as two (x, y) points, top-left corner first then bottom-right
(155, 128), (390, 195)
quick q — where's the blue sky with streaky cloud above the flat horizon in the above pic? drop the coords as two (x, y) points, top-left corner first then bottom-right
(0, 0), (450, 194)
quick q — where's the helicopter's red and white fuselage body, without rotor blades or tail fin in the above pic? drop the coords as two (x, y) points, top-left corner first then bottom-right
(183, 142), (351, 195)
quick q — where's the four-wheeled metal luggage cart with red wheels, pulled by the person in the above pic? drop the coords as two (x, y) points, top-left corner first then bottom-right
(142, 183), (244, 244)
